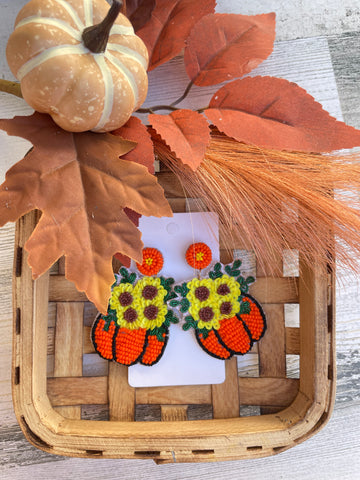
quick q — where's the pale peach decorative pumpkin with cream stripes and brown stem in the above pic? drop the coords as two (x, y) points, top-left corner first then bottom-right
(6, 0), (148, 132)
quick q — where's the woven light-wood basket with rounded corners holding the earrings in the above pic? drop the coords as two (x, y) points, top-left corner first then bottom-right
(13, 172), (335, 463)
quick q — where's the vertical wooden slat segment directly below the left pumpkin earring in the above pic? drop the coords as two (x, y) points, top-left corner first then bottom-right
(108, 362), (135, 422)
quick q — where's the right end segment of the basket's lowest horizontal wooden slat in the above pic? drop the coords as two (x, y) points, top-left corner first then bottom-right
(239, 377), (299, 407)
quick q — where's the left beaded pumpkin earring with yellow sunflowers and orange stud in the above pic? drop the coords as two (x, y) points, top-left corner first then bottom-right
(91, 248), (179, 366)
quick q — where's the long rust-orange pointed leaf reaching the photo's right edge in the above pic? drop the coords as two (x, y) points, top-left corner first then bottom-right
(205, 77), (360, 153)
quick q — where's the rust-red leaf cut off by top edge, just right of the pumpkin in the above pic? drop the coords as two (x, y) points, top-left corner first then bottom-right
(137, 0), (216, 70)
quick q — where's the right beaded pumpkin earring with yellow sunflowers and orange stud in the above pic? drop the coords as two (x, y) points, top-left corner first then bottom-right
(170, 243), (266, 360)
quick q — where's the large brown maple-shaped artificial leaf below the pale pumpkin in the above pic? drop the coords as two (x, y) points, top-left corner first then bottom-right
(0, 113), (171, 313)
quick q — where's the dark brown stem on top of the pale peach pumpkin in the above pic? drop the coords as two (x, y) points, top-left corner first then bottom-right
(82, 0), (123, 53)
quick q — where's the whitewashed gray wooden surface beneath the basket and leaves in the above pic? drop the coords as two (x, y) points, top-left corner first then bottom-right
(0, 0), (360, 480)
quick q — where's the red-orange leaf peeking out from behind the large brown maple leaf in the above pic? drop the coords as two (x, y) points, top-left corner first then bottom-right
(111, 117), (155, 267)
